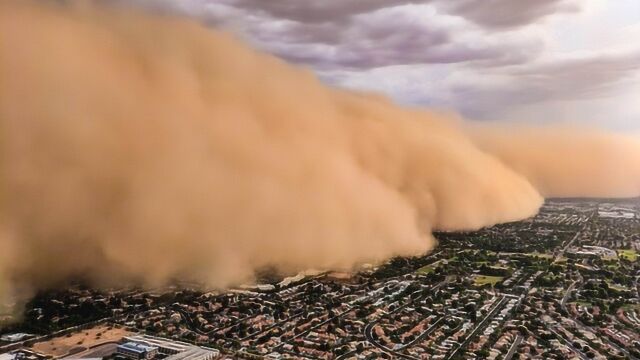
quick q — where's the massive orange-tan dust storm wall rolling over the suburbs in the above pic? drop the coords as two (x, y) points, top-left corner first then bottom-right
(0, 2), (640, 304)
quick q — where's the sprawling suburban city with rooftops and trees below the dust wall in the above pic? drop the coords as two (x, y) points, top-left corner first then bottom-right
(0, 199), (640, 360)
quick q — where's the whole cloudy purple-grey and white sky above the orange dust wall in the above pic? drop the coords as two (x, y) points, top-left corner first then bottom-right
(130, 0), (640, 131)
